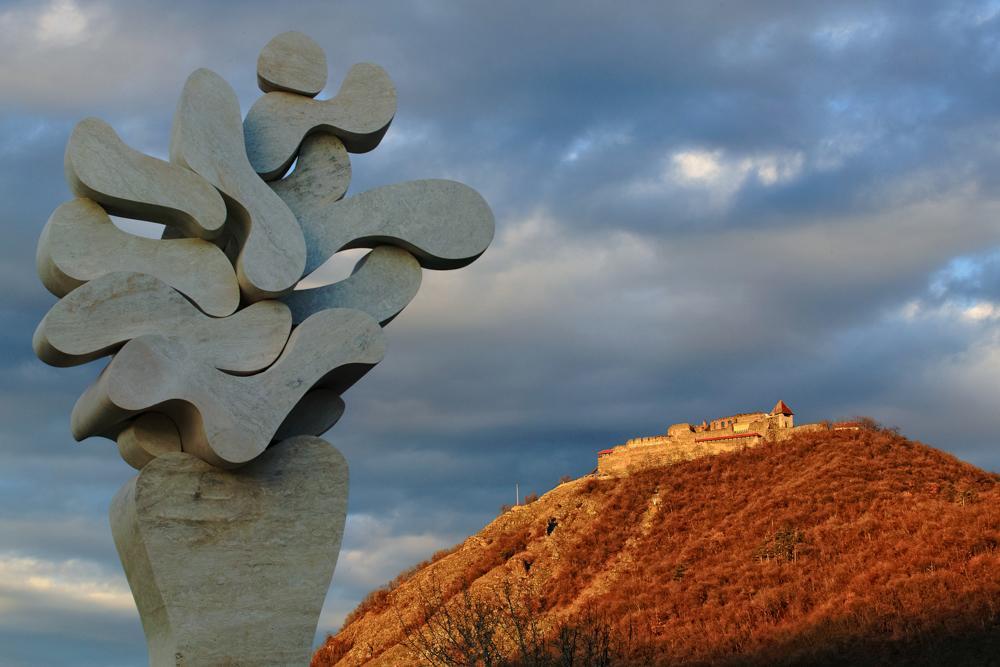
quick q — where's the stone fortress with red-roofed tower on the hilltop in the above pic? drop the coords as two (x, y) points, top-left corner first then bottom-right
(597, 401), (824, 477)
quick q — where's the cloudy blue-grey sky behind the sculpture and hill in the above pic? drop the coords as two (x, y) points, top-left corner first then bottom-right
(0, 0), (1000, 667)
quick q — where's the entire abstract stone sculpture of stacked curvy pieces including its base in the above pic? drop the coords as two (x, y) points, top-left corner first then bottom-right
(32, 28), (493, 667)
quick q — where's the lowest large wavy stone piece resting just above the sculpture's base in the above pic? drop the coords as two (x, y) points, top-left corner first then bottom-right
(71, 308), (385, 468)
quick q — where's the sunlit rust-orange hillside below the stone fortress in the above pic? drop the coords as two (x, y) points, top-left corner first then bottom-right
(312, 429), (1000, 667)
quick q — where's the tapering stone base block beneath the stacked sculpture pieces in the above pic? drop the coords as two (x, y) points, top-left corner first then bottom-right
(111, 436), (347, 667)
